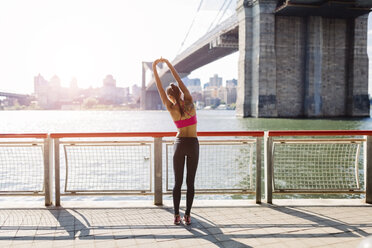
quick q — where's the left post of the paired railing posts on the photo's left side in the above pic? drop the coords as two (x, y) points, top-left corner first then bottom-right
(44, 134), (53, 206)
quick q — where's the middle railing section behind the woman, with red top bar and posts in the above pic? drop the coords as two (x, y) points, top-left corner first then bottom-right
(50, 131), (264, 206)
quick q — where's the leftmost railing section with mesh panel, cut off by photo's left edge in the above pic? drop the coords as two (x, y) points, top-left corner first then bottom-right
(0, 133), (53, 206)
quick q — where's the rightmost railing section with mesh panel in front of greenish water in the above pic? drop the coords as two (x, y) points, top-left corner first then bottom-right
(265, 130), (372, 203)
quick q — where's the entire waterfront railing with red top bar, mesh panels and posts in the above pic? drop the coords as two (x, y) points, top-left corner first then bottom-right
(0, 130), (372, 206)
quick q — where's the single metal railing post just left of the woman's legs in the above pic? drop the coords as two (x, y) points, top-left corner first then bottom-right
(154, 137), (163, 205)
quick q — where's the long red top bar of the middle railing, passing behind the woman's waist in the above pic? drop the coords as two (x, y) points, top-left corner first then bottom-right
(50, 131), (264, 138)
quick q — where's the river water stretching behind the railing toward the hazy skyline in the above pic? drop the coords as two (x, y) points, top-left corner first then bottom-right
(0, 110), (372, 200)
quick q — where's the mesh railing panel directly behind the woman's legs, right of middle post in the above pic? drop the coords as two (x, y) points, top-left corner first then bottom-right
(165, 139), (257, 194)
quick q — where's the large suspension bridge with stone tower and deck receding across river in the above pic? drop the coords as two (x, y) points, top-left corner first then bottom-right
(141, 0), (372, 117)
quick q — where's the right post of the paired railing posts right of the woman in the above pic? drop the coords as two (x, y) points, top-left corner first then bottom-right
(265, 133), (273, 204)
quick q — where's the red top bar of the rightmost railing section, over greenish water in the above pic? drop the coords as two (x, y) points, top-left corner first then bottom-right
(269, 130), (372, 137)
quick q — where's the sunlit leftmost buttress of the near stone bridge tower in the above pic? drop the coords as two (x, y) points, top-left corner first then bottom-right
(237, 0), (277, 117)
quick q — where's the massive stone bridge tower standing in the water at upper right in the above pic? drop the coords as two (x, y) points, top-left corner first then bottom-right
(236, 0), (370, 117)
